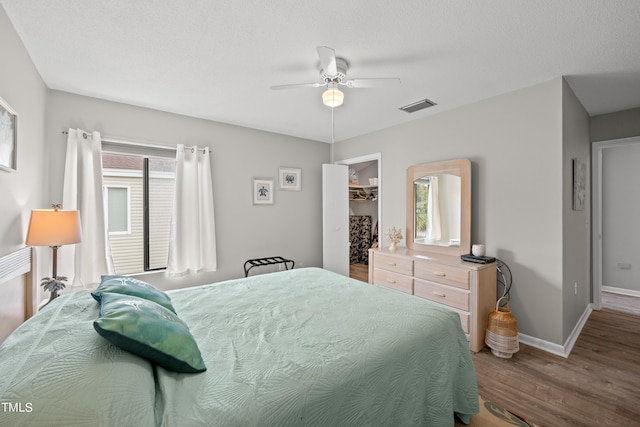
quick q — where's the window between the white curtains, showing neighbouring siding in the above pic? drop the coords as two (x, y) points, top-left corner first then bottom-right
(102, 152), (175, 274)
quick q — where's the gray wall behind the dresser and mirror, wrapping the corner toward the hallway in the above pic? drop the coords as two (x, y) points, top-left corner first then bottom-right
(334, 78), (589, 345)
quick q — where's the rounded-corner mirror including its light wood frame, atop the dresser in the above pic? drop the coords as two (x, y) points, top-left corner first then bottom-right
(406, 159), (471, 255)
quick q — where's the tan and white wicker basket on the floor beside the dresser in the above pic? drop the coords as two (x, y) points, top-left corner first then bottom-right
(484, 297), (520, 359)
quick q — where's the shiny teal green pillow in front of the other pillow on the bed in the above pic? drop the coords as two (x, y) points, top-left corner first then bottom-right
(93, 292), (207, 373)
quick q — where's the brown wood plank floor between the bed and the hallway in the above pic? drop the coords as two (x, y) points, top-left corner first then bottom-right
(473, 299), (640, 427)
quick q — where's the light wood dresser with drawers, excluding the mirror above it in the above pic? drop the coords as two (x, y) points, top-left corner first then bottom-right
(369, 248), (496, 352)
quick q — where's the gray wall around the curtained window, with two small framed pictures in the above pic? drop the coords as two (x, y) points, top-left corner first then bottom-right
(47, 91), (329, 289)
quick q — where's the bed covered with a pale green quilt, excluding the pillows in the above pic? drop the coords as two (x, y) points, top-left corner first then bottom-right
(0, 268), (479, 427)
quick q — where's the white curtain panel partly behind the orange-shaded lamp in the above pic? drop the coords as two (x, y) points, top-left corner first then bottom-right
(59, 129), (114, 287)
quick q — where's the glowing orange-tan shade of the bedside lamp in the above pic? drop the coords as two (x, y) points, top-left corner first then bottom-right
(26, 209), (82, 246)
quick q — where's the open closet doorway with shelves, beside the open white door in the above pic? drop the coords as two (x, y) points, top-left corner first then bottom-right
(335, 153), (382, 282)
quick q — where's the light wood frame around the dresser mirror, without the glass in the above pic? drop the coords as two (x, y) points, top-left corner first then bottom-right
(406, 159), (471, 256)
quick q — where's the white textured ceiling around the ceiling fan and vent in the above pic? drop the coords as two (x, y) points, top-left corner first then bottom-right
(0, 0), (640, 142)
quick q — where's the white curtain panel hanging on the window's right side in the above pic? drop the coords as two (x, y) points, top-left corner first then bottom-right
(167, 144), (217, 276)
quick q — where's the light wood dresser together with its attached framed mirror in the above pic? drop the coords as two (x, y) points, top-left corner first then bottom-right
(369, 159), (496, 352)
